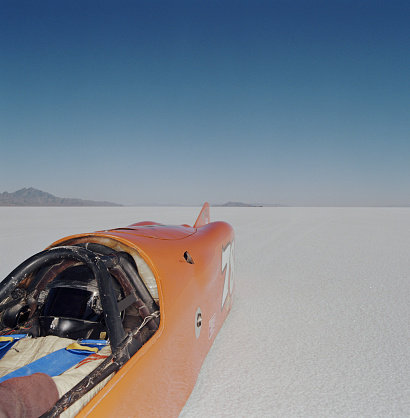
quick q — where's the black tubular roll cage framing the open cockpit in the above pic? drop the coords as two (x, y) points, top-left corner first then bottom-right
(0, 243), (159, 417)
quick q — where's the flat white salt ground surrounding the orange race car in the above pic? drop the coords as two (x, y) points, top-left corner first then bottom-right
(0, 208), (410, 418)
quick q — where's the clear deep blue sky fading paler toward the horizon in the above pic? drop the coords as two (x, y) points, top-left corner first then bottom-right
(0, 0), (410, 206)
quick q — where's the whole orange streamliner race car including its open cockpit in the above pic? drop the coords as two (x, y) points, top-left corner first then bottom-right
(0, 203), (234, 417)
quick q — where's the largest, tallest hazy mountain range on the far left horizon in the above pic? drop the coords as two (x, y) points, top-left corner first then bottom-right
(0, 187), (122, 206)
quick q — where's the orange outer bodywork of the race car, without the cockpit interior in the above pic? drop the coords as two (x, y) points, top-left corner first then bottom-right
(41, 204), (234, 417)
